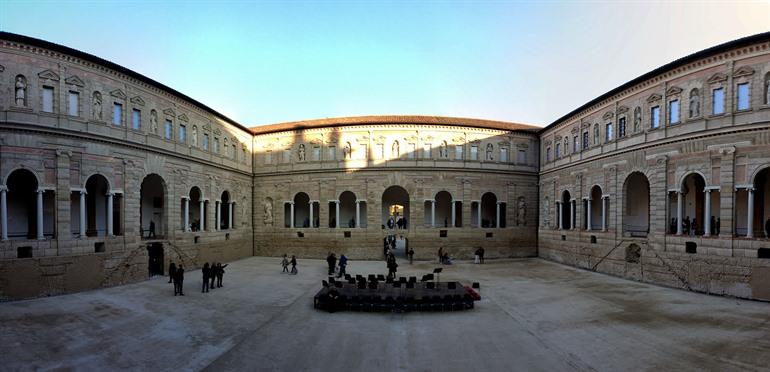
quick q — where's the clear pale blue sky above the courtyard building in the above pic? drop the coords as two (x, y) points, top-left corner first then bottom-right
(0, 0), (770, 126)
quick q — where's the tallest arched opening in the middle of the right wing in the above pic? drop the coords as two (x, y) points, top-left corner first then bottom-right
(623, 172), (650, 236)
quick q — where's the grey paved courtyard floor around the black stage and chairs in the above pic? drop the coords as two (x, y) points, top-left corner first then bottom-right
(0, 257), (770, 372)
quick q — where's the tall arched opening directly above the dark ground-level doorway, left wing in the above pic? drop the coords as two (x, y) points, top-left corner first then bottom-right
(139, 174), (166, 239)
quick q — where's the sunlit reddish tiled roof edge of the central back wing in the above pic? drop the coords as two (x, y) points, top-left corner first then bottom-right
(251, 115), (541, 135)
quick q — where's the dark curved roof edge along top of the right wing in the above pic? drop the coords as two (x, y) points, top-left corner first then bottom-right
(538, 31), (770, 134)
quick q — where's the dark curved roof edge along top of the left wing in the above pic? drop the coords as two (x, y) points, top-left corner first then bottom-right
(0, 31), (251, 133)
